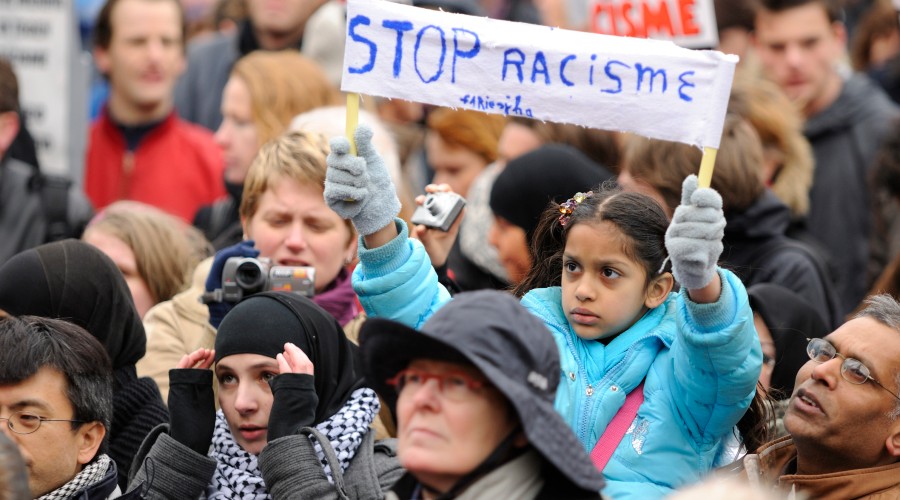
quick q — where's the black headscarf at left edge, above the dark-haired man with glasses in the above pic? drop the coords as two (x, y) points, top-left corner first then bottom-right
(0, 239), (147, 369)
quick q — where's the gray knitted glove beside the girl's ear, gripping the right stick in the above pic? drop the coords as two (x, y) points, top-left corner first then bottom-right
(666, 175), (725, 290)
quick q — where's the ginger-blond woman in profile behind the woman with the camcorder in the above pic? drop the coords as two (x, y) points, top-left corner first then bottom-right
(194, 50), (339, 249)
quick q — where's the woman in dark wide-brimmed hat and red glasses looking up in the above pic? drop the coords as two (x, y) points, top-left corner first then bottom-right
(360, 291), (603, 499)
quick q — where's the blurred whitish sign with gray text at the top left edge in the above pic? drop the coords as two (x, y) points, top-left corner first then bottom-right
(0, 0), (87, 181)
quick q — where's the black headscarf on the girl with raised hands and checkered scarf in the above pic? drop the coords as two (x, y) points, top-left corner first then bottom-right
(215, 292), (363, 425)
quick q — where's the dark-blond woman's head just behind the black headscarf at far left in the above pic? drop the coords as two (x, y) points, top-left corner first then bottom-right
(81, 201), (212, 317)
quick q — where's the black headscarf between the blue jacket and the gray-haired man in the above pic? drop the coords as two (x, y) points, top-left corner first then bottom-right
(747, 283), (829, 399)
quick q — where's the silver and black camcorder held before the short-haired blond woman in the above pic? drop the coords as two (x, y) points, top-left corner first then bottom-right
(222, 257), (316, 302)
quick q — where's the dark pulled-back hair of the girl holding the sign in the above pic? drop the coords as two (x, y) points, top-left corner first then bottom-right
(513, 181), (669, 297)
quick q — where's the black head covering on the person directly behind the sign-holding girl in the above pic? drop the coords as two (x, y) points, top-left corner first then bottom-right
(491, 144), (613, 241)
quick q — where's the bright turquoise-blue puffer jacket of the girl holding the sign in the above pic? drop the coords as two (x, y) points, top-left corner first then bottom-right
(353, 219), (762, 499)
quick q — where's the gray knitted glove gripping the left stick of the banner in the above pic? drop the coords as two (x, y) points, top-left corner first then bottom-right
(325, 125), (400, 236)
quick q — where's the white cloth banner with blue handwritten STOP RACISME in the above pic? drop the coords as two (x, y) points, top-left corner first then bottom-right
(341, 0), (738, 148)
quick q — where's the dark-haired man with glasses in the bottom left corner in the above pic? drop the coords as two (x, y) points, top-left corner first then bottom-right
(0, 316), (133, 500)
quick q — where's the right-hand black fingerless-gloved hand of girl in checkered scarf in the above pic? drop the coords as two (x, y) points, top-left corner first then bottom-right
(266, 343), (319, 442)
